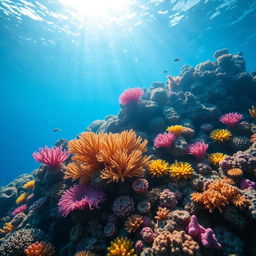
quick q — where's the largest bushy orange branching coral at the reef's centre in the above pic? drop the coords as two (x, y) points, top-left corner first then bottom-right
(65, 130), (151, 183)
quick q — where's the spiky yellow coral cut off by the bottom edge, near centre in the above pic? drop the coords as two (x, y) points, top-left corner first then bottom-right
(107, 237), (137, 256)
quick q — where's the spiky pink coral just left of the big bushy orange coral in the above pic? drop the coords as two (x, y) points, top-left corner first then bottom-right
(33, 146), (69, 166)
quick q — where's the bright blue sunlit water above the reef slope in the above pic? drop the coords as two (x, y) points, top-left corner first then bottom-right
(0, 0), (256, 185)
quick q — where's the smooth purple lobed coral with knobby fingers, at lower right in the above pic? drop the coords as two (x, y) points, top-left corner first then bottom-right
(187, 215), (221, 249)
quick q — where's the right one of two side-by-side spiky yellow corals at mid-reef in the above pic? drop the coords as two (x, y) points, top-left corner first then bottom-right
(169, 162), (194, 179)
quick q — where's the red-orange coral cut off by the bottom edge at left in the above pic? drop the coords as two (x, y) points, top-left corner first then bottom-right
(24, 242), (55, 256)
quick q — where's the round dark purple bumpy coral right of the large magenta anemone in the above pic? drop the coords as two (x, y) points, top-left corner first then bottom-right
(113, 196), (134, 218)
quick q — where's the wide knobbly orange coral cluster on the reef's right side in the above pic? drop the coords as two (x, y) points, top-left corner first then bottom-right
(191, 179), (248, 212)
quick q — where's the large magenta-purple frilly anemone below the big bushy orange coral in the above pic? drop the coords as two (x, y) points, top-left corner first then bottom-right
(58, 183), (105, 217)
